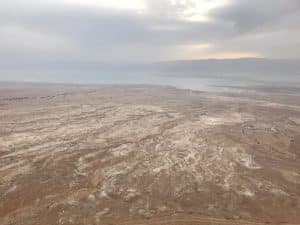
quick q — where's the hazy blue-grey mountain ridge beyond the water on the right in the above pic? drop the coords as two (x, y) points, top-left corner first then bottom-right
(152, 58), (300, 76)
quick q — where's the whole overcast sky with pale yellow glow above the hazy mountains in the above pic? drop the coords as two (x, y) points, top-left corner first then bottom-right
(0, 0), (300, 82)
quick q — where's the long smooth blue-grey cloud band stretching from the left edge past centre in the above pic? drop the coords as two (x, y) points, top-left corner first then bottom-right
(0, 4), (226, 47)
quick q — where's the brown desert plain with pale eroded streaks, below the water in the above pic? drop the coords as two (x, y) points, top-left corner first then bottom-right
(0, 84), (300, 225)
